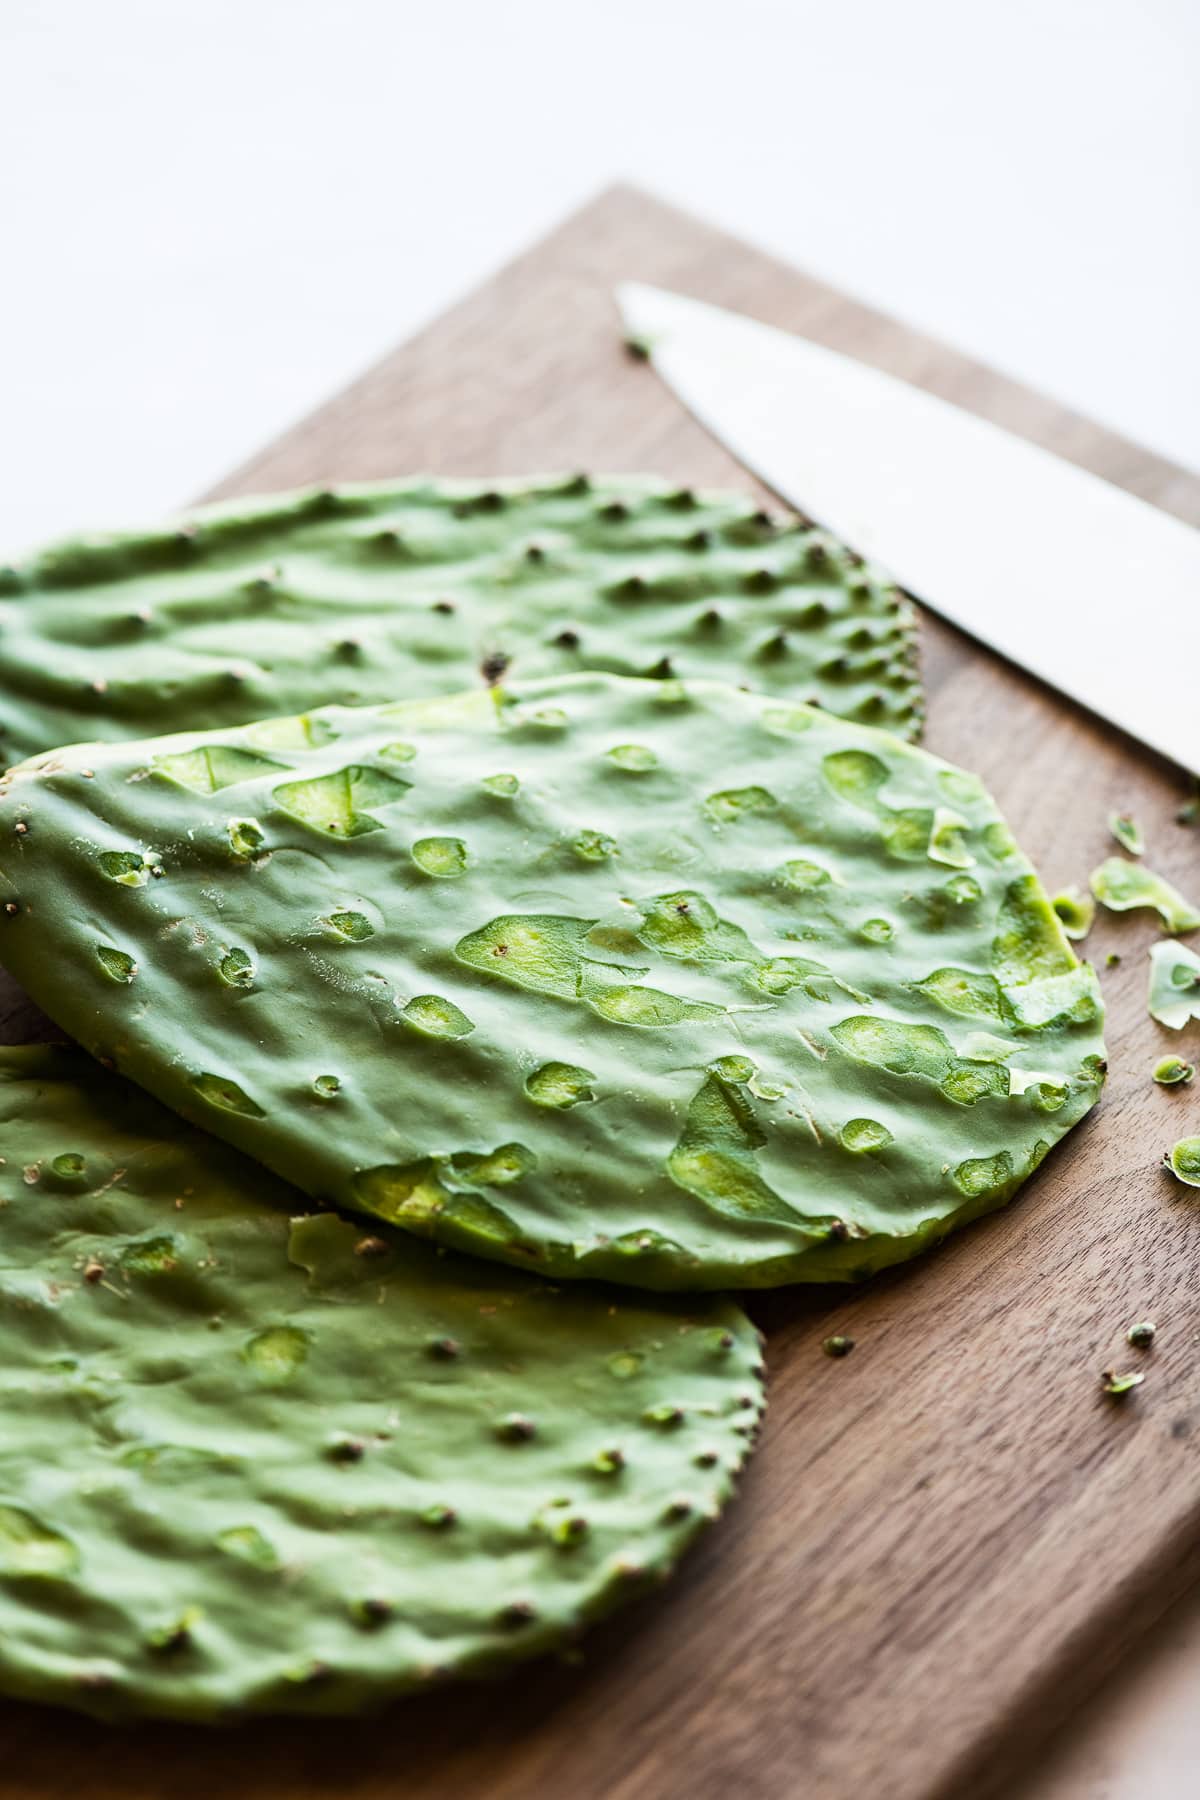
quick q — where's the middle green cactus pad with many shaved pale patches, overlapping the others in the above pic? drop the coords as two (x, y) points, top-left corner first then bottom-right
(0, 675), (1103, 1287)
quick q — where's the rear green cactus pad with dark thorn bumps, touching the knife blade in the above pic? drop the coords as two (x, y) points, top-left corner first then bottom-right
(0, 477), (923, 767)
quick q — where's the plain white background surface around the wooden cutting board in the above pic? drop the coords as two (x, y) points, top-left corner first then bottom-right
(0, 0), (1200, 1800)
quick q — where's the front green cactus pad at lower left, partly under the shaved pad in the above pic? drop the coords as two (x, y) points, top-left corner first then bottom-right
(0, 1048), (761, 1719)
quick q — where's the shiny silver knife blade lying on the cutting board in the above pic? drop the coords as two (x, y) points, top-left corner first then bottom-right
(617, 283), (1200, 772)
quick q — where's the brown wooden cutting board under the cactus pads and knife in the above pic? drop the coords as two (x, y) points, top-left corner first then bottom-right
(0, 189), (1200, 1800)
